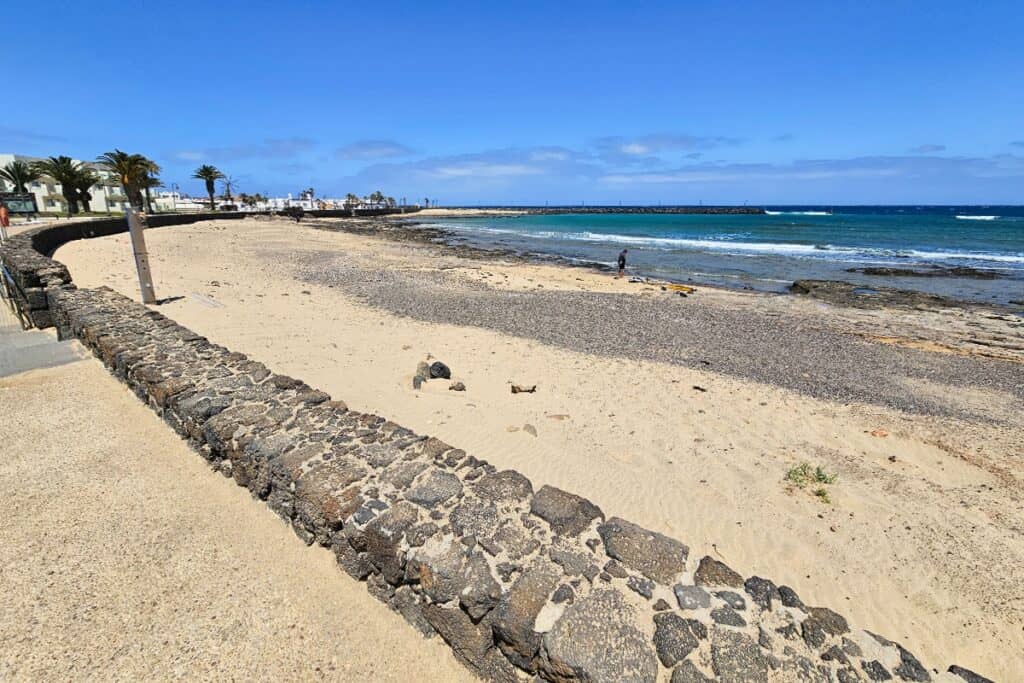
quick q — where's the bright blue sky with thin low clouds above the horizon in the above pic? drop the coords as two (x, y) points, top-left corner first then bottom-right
(0, 0), (1024, 205)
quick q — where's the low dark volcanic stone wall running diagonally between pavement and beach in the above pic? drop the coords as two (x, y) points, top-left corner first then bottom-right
(0, 222), (986, 683)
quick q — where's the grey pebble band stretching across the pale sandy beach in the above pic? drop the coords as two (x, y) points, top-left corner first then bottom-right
(289, 240), (1024, 421)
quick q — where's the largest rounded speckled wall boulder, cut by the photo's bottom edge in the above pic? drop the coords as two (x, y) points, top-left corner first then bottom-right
(544, 590), (657, 683)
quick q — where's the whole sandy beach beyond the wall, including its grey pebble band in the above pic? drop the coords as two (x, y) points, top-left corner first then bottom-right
(55, 218), (1024, 680)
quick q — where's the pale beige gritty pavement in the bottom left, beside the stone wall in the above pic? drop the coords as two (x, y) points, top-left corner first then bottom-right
(0, 359), (474, 682)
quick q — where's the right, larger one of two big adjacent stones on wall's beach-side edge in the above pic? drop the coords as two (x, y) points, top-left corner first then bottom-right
(597, 517), (689, 584)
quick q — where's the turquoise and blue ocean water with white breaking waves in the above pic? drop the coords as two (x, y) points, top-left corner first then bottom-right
(422, 206), (1024, 303)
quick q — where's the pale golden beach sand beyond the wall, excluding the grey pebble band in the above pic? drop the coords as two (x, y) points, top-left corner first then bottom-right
(56, 220), (1024, 680)
